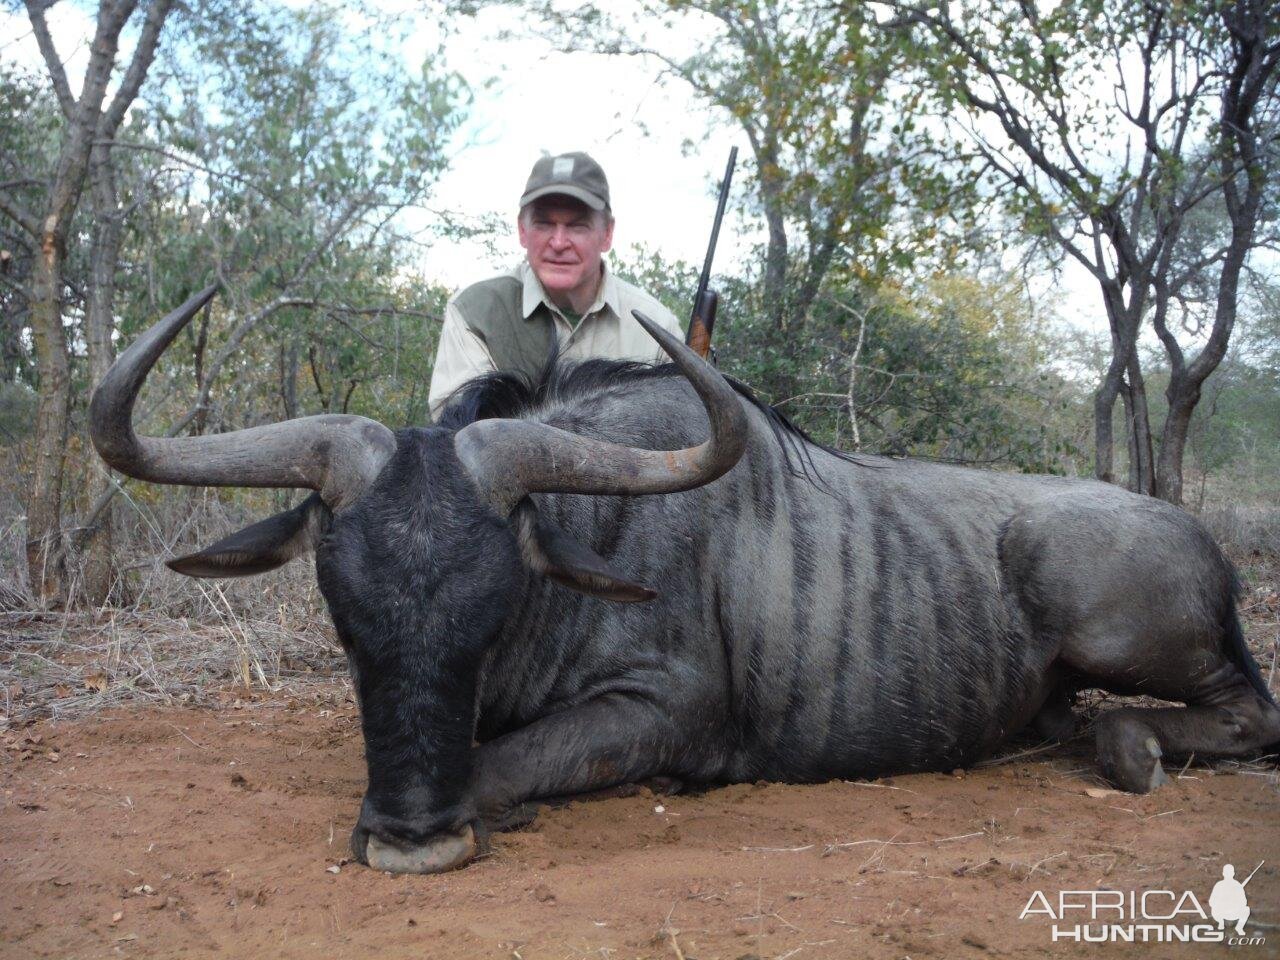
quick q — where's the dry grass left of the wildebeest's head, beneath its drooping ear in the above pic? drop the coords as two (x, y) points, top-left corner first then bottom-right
(0, 490), (347, 726)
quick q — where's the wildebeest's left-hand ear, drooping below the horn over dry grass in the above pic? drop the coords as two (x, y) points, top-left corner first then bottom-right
(165, 493), (329, 577)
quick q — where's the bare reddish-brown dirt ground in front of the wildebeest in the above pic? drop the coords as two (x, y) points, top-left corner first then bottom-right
(0, 700), (1280, 960)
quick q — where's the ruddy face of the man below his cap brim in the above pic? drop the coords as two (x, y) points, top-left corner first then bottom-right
(517, 196), (613, 307)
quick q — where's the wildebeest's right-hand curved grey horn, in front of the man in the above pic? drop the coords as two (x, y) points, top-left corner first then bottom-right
(453, 310), (746, 515)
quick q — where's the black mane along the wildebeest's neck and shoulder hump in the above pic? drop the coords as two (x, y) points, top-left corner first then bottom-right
(438, 357), (863, 481)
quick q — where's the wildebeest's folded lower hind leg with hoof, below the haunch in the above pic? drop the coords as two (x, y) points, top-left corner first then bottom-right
(1094, 664), (1280, 794)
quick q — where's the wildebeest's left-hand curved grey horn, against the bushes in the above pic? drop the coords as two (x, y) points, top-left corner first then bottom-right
(88, 284), (396, 509)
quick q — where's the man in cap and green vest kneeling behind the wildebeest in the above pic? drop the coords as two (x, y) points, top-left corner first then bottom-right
(428, 152), (682, 420)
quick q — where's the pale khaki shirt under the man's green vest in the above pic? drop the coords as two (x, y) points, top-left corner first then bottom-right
(428, 262), (684, 420)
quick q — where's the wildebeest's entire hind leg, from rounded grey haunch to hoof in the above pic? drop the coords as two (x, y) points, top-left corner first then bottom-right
(1001, 512), (1280, 794)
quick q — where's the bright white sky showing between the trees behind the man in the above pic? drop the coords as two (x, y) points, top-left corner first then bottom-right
(0, 0), (1101, 329)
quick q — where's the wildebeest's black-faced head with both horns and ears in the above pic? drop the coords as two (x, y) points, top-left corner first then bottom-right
(90, 287), (746, 872)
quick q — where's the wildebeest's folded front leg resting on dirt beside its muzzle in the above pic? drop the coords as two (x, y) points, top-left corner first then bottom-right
(474, 694), (680, 829)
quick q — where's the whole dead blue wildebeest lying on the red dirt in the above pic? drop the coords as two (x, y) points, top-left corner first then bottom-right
(91, 289), (1280, 872)
